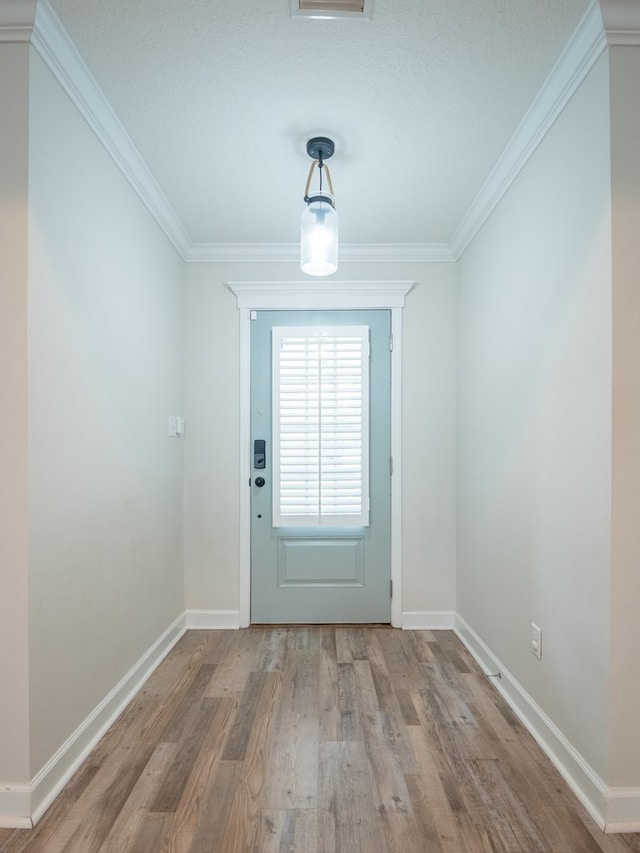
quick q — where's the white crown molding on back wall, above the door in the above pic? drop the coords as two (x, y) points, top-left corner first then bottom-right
(186, 243), (455, 263)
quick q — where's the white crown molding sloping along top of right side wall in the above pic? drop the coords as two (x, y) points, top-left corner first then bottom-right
(451, 0), (608, 260)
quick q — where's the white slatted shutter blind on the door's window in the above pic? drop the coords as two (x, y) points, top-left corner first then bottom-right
(273, 326), (369, 527)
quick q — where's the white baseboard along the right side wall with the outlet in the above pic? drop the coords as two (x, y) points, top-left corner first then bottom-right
(454, 614), (609, 830)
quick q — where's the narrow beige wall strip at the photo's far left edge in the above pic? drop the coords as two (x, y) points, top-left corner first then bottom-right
(0, 44), (29, 790)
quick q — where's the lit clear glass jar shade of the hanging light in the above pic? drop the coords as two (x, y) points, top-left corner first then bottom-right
(300, 192), (338, 275)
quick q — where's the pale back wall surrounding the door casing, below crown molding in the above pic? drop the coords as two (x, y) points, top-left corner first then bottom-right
(184, 263), (456, 612)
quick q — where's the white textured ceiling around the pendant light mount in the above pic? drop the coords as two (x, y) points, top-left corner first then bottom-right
(50, 0), (589, 243)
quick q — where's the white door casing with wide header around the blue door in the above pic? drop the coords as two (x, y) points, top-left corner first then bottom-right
(227, 281), (415, 628)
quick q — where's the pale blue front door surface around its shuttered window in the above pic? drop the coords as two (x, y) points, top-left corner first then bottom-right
(251, 310), (391, 623)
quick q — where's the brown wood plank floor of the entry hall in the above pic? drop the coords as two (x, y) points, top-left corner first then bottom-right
(0, 626), (640, 853)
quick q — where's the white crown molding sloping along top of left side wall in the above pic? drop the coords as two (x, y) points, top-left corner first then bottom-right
(31, 0), (191, 259)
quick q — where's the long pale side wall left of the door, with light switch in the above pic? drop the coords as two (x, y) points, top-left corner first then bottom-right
(28, 52), (184, 774)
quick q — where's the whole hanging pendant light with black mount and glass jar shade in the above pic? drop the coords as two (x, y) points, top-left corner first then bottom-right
(300, 136), (338, 275)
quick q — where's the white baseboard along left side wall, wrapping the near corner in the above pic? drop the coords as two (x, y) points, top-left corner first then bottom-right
(0, 613), (187, 829)
